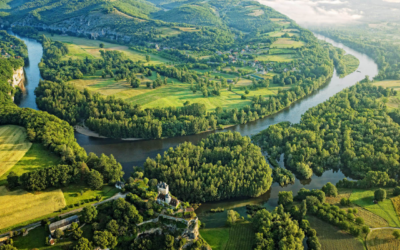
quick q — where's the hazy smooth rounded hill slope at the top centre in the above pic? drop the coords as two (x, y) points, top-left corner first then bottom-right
(154, 4), (222, 26)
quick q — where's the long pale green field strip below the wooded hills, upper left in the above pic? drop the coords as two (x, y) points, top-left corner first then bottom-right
(42, 32), (169, 64)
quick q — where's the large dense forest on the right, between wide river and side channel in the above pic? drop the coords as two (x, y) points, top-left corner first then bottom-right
(254, 79), (400, 179)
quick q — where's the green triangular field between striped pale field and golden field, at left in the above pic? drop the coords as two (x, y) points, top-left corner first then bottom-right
(0, 143), (61, 186)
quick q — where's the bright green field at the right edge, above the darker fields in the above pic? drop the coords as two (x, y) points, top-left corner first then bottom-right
(350, 190), (400, 227)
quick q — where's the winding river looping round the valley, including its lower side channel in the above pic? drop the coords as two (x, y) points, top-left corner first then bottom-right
(15, 34), (378, 227)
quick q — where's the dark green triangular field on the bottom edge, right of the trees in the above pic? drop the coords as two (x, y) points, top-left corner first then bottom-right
(307, 216), (364, 250)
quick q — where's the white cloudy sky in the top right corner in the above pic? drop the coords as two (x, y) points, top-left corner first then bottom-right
(259, 0), (400, 26)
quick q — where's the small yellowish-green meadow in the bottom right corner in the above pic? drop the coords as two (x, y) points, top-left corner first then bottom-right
(367, 229), (400, 250)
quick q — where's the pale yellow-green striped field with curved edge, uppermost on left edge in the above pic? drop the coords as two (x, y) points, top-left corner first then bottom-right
(0, 125), (32, 179)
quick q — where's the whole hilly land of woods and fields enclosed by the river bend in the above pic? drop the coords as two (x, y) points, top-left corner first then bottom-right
(4, 1), (340, 139)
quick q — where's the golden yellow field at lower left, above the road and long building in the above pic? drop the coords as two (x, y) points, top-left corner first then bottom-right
(0, 186), (66, 229)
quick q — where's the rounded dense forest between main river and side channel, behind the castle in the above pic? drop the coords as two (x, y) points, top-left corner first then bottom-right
(144, 132), (272, 202)
